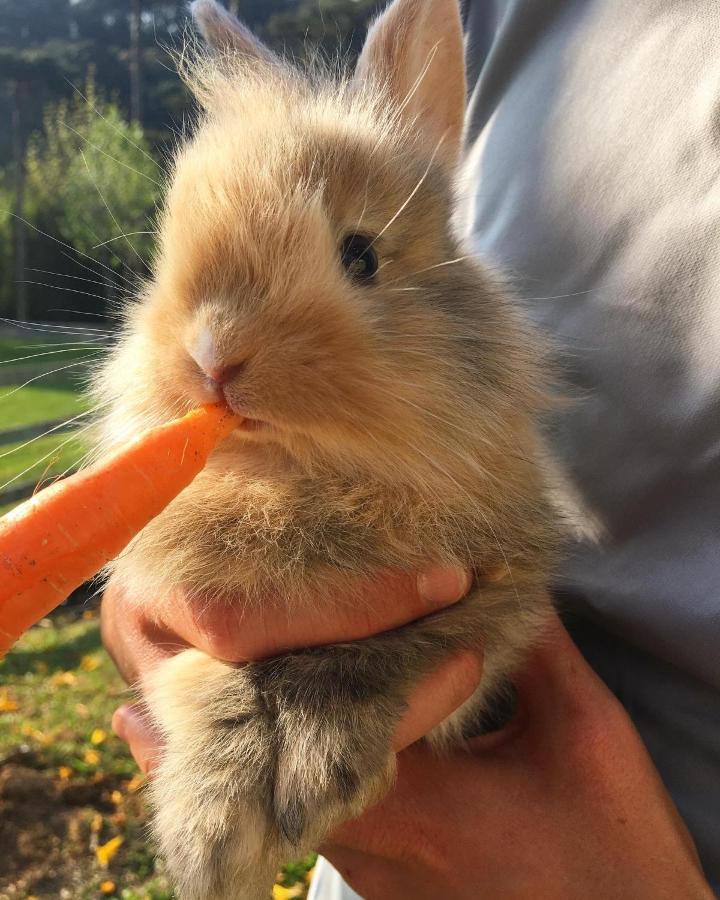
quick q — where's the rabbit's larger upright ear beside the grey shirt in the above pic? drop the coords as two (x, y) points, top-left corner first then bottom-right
(356, 0), (466, 166)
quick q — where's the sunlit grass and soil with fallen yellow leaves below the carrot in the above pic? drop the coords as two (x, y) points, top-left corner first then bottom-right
(0, 608), (315, 900)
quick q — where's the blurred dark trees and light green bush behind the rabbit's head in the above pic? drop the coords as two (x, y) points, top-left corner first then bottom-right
(0, 0), (380, 321)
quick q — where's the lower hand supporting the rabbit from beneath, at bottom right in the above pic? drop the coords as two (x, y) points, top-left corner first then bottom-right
(321, 622), (714, 900)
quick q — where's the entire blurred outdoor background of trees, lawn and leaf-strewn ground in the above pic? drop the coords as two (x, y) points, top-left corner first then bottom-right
(0, 0), (382, 900)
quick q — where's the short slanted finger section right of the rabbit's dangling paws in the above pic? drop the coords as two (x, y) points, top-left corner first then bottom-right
(393, 652), (482, 752)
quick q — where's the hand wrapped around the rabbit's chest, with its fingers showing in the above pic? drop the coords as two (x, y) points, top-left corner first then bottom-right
(101, 570), (481, 772)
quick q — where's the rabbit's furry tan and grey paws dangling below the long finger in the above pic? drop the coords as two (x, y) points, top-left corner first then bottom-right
(148, 650), (394, 900)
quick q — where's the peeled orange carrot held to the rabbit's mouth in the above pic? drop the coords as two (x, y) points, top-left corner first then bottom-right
(0, 406), (240, 659)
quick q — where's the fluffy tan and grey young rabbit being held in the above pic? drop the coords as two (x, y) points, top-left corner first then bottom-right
(97, 0), (556, 900)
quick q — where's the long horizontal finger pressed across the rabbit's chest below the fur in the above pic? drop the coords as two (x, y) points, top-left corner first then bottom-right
(157, 569), (471, 662)
